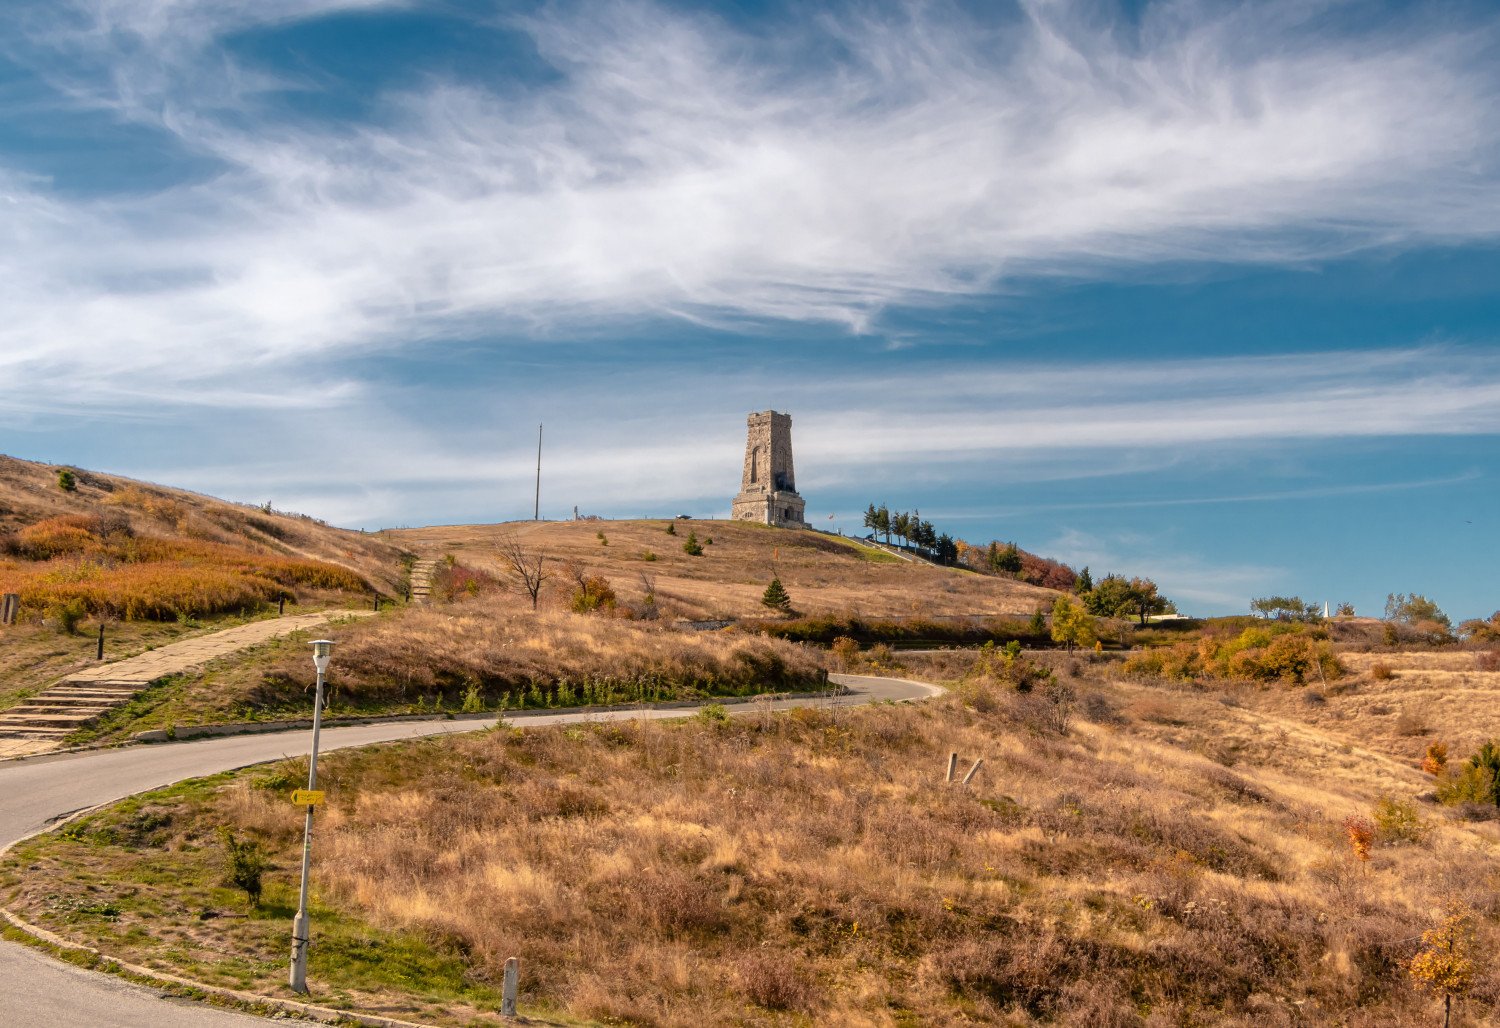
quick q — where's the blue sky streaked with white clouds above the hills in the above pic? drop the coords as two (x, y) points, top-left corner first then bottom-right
(0, 0), (1500, 617)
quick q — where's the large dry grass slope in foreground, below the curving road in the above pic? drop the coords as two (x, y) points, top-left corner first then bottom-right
(11, 663), (1500, 1025)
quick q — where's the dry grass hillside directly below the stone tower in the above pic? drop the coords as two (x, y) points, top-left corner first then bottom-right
(381, 521), (1056, 618)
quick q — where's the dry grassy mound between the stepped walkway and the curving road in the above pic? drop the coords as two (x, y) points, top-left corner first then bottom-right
(92, 597), (825, 738)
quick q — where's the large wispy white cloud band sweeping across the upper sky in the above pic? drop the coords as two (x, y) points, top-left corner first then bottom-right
(0, 0), (1500, 411)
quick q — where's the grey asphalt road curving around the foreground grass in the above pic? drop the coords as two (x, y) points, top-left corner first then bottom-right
(0, 675), (942, 1028)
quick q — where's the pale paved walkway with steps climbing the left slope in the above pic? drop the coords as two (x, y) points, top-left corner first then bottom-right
(0, 611), (372, 758)
